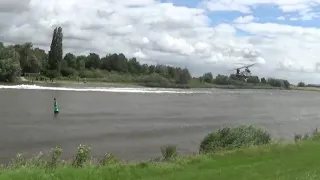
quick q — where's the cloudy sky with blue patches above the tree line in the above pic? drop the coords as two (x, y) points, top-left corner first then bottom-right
(0, 0), (320, 84)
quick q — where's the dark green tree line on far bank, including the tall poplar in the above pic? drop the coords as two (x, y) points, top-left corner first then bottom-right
(0, 27), (289, 87)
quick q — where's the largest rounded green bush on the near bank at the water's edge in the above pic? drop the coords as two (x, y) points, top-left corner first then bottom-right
(200, 125), (271, 153)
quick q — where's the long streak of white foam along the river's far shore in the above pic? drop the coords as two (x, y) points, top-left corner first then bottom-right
(0, 84), (210, 94)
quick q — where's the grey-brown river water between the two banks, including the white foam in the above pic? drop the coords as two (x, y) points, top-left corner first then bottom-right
(0, 85), (320, 163)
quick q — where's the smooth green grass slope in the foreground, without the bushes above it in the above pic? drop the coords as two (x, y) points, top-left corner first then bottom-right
(0, 140), (320, 180)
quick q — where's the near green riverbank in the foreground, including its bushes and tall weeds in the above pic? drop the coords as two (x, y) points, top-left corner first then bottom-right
(0, 127), (320, 180)
